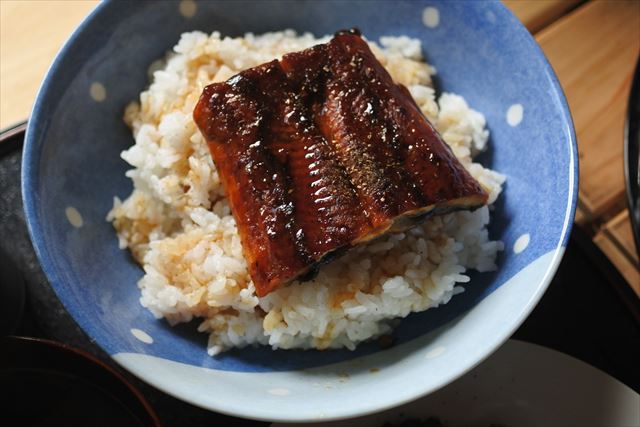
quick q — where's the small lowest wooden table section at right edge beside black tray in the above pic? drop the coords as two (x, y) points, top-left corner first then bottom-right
(594, 210), (640, 297)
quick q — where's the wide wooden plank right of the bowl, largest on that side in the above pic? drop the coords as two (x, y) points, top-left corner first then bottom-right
(536, 1), (640, 222)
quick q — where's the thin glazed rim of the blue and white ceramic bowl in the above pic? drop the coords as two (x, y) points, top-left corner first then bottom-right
(21, 0), (579, 422)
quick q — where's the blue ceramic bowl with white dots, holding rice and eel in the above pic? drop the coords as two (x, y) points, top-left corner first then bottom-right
(22, 0), (578, 421)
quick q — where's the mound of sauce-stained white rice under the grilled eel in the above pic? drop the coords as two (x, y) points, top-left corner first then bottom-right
(107, 30), (504, 355)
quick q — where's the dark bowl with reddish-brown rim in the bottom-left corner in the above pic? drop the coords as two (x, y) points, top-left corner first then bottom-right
(0, 337), (160, 427)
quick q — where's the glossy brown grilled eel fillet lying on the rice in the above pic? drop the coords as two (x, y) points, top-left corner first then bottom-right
(194, 30), (487, 296)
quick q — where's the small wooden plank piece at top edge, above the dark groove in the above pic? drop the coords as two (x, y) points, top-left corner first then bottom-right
(502, 0), (582, 33)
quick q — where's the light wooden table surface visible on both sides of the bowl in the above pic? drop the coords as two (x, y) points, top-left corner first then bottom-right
(0, 0), (640, 296)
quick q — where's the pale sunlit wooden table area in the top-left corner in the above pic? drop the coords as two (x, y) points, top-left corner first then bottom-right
(0, 0), (98, 128)
